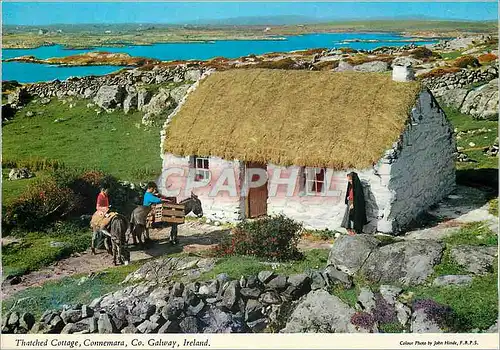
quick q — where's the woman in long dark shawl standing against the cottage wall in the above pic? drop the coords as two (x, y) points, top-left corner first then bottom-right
(341, 172), (368, 235)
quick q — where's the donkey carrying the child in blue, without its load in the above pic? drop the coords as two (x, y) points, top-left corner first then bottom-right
(130, 193), (203, 245)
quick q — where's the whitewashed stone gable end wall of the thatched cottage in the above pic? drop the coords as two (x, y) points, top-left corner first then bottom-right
(377, 92), (456, 231)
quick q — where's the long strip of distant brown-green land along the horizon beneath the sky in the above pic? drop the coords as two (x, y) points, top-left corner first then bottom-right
(3, 19), (498, 49)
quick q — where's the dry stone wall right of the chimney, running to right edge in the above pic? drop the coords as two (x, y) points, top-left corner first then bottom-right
(422, 66), (498, 97)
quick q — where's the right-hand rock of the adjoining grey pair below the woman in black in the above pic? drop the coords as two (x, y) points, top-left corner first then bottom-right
(360, 240), (444, 286)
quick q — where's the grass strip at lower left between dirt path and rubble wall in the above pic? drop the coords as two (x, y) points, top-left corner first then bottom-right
(2, 261), (144, 318)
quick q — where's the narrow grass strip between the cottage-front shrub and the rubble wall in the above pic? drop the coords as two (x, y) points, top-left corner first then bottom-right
(199, 249), (330, 280)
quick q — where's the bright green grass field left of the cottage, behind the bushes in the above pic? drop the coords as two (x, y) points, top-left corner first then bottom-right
(2, 99), (161, 182)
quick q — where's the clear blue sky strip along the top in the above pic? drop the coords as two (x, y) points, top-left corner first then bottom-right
(2, 1), (498, 25)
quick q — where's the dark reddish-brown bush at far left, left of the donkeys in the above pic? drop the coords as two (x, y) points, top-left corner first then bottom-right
(4, 179), (81, 229)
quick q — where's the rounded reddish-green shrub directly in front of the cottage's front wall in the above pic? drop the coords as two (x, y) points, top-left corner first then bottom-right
(215, 215), (302, 261)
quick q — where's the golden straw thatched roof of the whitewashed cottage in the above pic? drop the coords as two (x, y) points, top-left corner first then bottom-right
(164, 69), (421, 169)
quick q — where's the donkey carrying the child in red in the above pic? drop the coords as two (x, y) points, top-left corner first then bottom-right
(91, 214), (130, 265)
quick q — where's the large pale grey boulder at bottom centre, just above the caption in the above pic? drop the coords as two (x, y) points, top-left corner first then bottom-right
(280, 289), (356, 333)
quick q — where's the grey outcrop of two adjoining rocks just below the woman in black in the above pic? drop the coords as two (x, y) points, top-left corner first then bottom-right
(328, 235), (444, 286)
